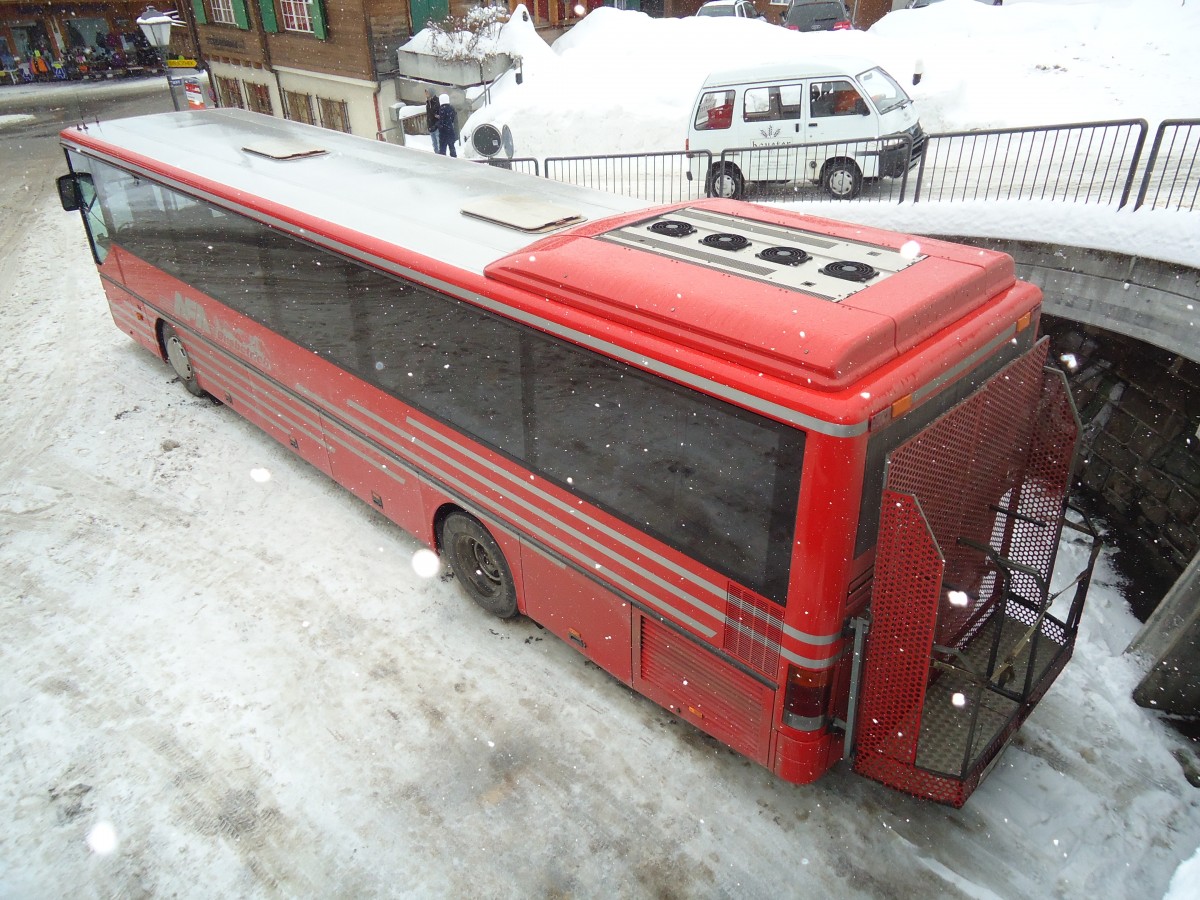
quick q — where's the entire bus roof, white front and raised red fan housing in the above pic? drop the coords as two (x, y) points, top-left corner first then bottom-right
(62, 109), (1038, 391)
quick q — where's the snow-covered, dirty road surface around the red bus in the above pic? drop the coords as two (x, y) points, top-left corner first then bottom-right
(0, 8), (1200, 899)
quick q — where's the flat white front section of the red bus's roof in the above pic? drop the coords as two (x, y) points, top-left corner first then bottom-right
(64, 109), (648, 274)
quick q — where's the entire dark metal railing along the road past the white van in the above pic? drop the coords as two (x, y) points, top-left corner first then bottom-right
(506, 119), (1200, 211)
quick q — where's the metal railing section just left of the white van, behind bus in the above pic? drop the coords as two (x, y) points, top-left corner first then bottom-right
(546, 150), (712, 203)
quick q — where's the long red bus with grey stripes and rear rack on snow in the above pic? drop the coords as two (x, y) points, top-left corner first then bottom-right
(59, 109), (1087, 805)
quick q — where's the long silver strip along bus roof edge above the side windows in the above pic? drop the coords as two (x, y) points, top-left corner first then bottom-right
(73, 148), (870, 438)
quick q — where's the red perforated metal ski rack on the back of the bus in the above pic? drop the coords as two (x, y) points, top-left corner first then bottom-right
(854, 341), (1079, 806)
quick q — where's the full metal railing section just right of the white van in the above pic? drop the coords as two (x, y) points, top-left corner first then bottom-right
(913, 119), (1147, 208)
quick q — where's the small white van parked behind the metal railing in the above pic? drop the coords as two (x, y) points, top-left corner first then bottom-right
(686, 59), (925, 199)
